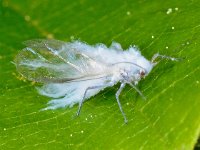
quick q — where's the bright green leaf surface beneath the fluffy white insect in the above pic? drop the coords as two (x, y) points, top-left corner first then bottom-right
(0, 0), (200, 150)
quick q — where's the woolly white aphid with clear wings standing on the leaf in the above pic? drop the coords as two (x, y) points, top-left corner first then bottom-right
(14, 40), (176, 123)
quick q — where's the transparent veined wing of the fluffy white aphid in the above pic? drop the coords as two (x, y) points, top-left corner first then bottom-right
(14, 40), (106, 82)
